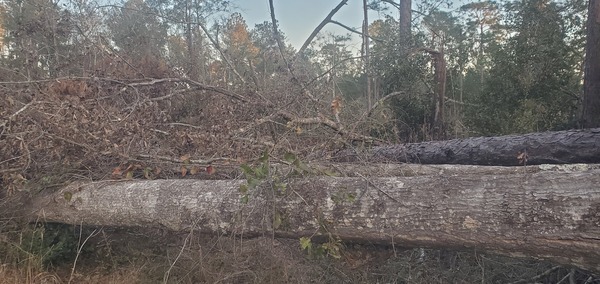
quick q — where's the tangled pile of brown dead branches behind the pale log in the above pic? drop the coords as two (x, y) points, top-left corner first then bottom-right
(0, 60), (390, 194)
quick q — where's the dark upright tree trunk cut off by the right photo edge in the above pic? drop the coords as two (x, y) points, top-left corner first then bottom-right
(582, 0), (600, 127)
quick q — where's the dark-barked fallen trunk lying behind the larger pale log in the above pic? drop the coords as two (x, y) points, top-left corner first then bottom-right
(334, 128), (600, 166)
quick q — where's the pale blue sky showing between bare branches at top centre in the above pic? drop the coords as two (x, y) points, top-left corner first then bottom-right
(232, 0), (392, 49)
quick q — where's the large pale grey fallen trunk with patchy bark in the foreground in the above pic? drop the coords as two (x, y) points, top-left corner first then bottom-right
(29, 165), (600, 273)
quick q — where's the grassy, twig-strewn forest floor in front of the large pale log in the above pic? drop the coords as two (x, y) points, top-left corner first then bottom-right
(0, 222), (600, 284)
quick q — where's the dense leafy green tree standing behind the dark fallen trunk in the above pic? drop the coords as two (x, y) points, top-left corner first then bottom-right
(469, 0), (580, 135)
